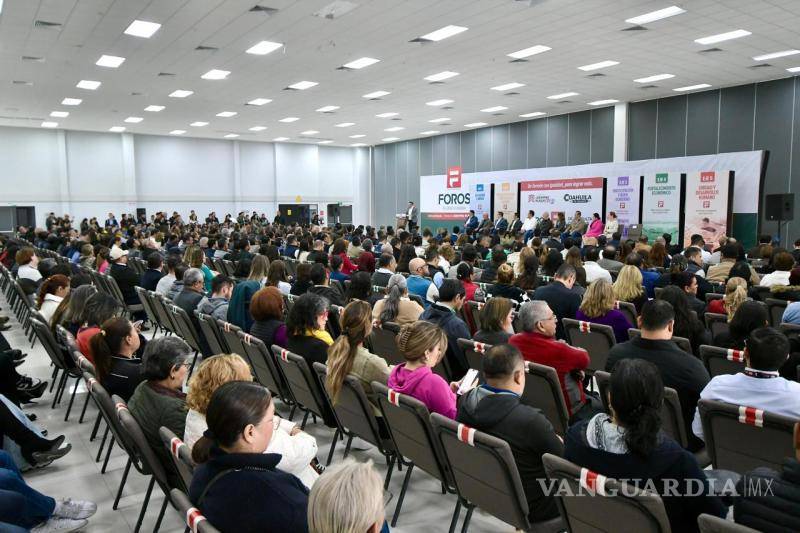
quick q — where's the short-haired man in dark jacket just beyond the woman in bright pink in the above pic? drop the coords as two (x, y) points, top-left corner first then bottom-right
(419, 279), (470, 380)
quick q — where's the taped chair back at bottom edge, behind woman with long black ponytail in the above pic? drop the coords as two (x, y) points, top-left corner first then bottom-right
(542, 453), (671, 533)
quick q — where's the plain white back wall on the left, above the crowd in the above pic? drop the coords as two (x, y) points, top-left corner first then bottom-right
(0, 127), (370, 229)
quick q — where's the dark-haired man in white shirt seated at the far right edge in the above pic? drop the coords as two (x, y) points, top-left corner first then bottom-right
(692, 328), (800, 439)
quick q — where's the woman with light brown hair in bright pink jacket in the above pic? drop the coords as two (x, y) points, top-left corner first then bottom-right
(388, 320), (458, 420)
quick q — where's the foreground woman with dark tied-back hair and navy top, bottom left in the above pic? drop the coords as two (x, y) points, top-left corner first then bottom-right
(190, 381), (308, 533)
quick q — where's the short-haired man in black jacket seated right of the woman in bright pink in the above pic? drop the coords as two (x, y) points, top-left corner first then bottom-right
(456, 344), (563, 523)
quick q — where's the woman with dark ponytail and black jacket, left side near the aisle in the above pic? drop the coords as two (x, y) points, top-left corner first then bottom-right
(89, 317), (144, 402)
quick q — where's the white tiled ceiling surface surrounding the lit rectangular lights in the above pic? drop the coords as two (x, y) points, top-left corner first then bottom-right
(0, 0), (800, 146)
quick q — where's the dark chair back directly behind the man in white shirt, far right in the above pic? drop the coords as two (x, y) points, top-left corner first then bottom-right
(697, 399), (797, 474)
